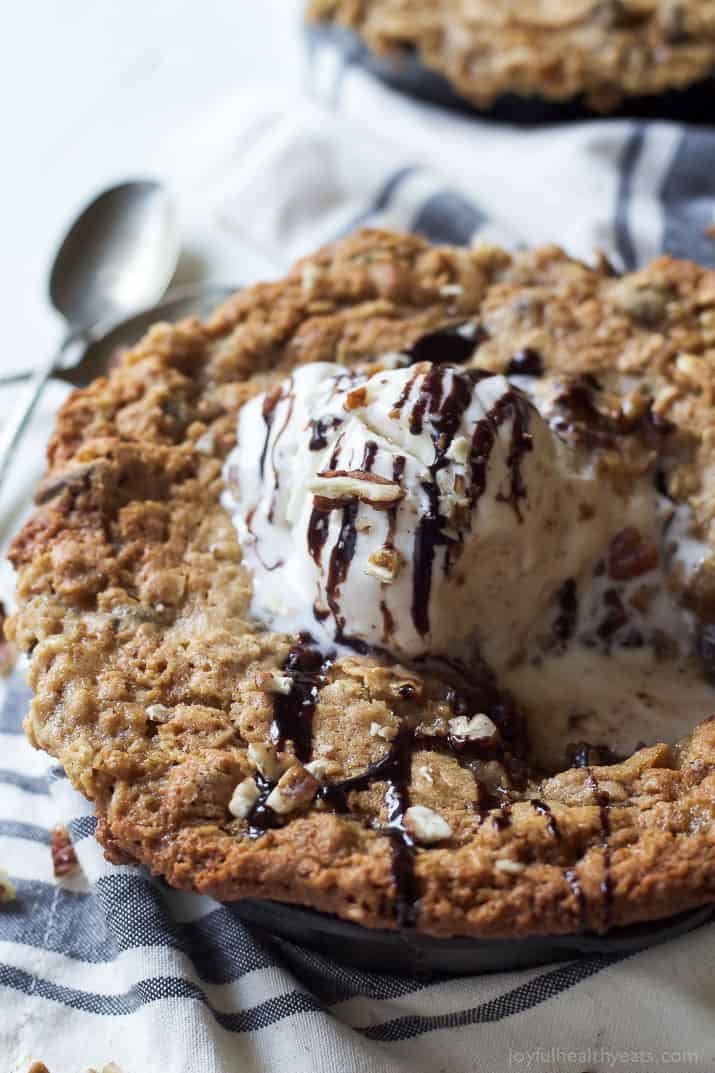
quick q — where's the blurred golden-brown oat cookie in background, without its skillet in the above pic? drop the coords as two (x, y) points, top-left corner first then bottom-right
(308, 0), (715, 112)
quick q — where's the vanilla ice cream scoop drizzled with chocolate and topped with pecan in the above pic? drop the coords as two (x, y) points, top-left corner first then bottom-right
(223, 362), (638, 670)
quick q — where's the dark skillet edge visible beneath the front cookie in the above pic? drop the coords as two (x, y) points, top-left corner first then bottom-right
(233, 899), (715, 976)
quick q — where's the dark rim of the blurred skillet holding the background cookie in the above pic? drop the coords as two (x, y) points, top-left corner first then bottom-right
(306, 23), (715, 126)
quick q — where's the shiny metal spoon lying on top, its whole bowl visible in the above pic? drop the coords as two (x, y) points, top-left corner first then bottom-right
(0, 180), (179, 485)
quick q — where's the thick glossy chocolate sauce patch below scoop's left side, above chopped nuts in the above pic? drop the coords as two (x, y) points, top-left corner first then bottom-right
(271, 644), (331, 764)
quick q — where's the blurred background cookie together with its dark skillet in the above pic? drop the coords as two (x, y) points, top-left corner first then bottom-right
(307, 0), (715, 123)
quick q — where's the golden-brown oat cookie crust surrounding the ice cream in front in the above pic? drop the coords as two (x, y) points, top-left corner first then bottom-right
(9, 231), (715, 936)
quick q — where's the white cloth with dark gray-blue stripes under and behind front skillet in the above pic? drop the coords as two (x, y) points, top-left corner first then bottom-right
(0, 39), (715, 1073)
